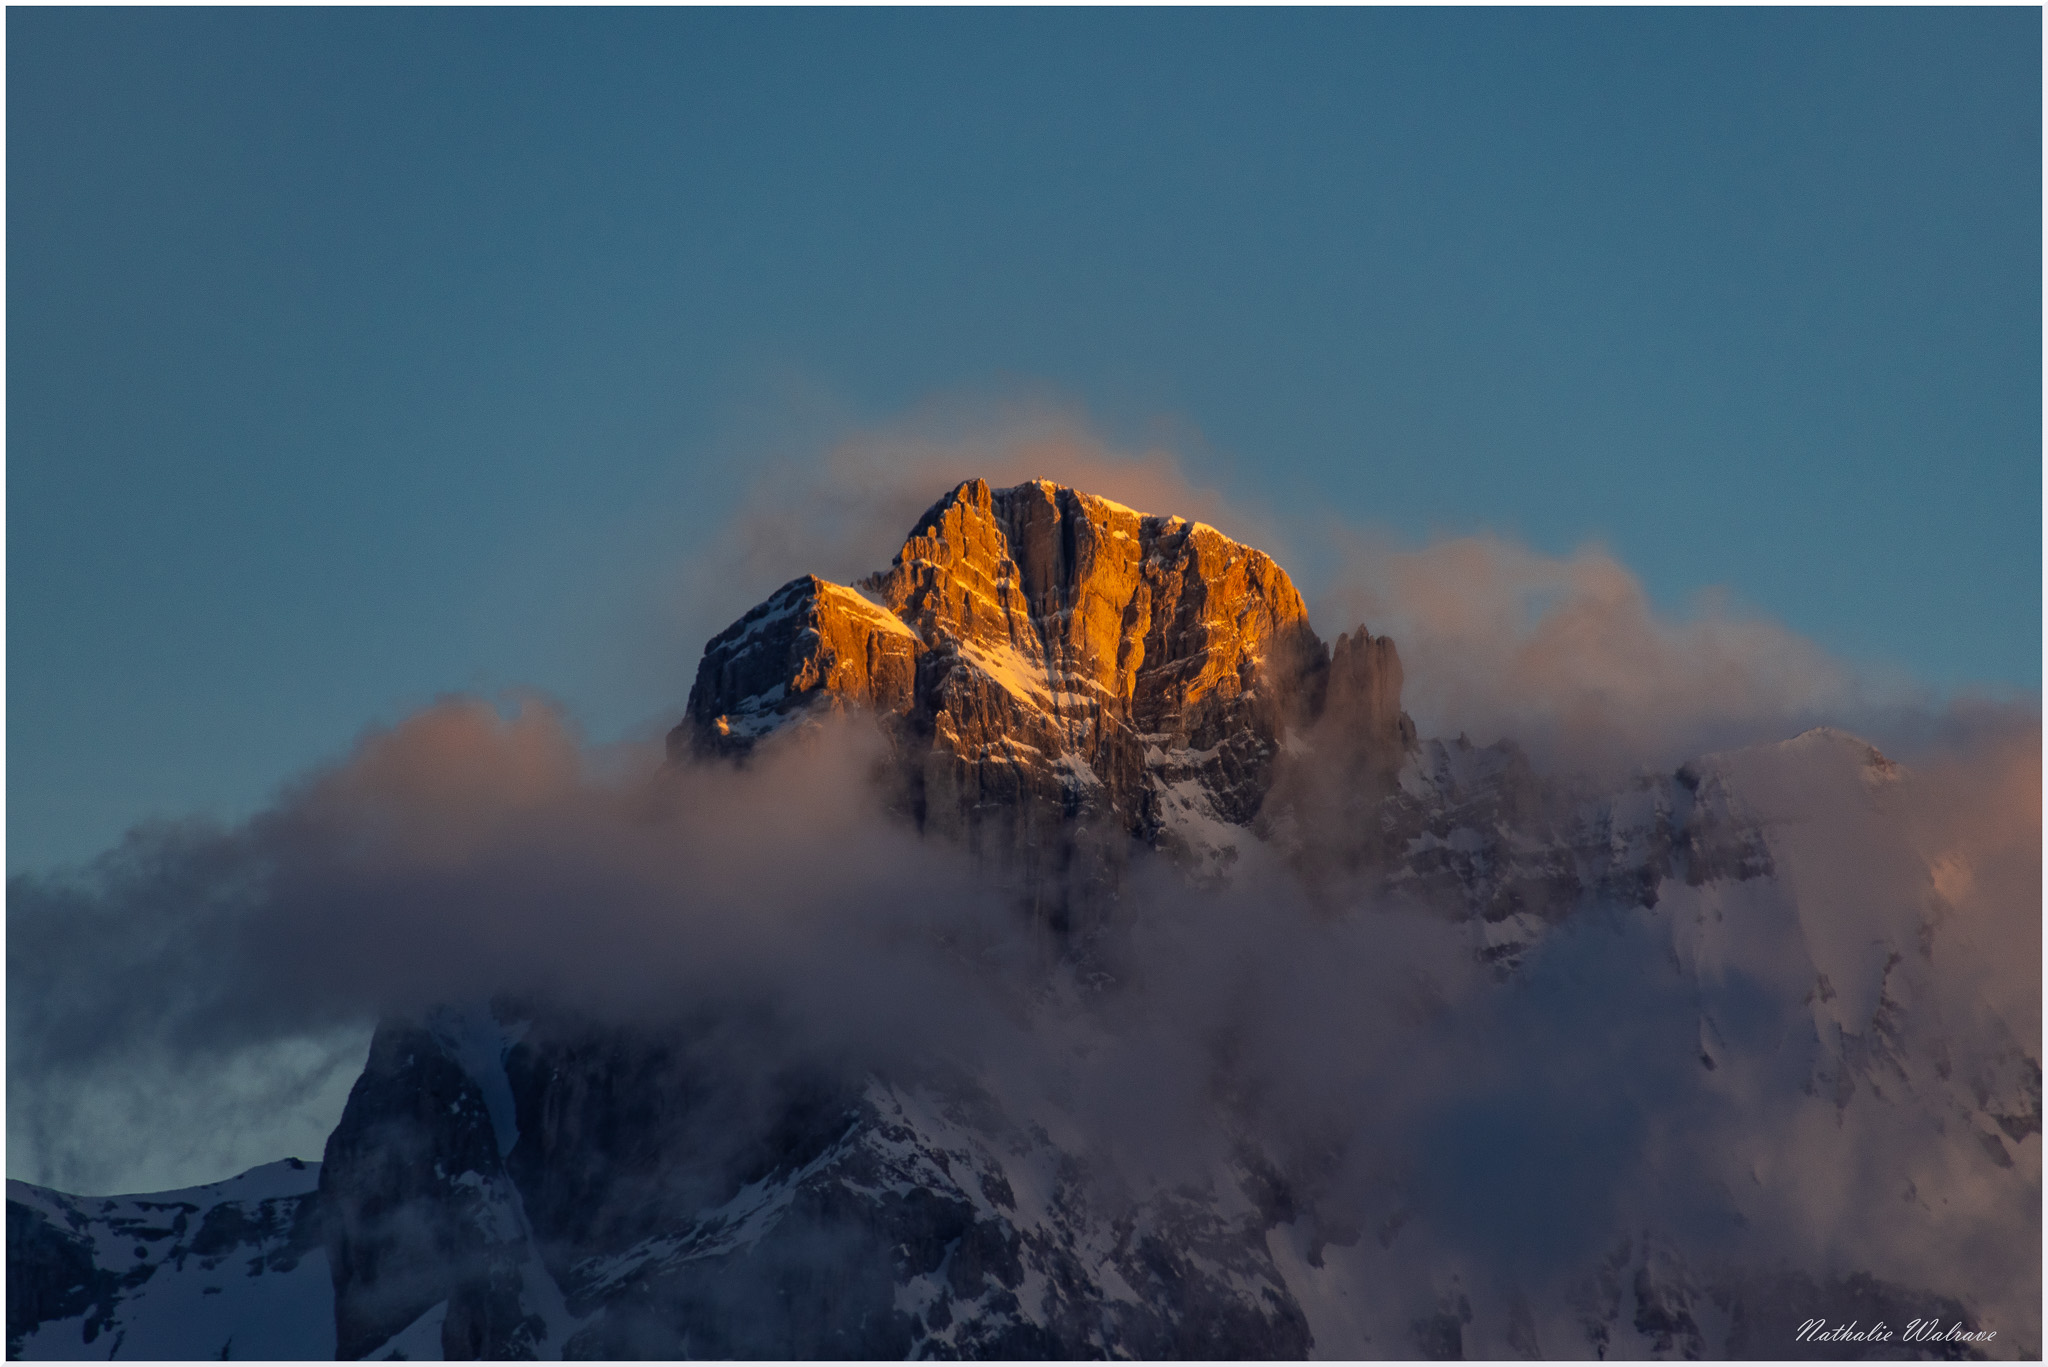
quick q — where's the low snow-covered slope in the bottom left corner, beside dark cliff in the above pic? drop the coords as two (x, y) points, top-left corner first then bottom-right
(6, 1158), (334, 1359)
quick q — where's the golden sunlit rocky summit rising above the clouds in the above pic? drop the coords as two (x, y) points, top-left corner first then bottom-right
(670, 480), (1413, 901)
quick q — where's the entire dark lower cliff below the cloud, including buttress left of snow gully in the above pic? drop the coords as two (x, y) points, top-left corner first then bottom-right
(299, 1002), (1309, 1359)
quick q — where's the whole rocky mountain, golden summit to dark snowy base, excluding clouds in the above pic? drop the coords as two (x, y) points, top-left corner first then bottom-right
(8, 480), (2042, 1359)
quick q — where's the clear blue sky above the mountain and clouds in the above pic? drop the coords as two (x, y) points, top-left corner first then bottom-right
(6, 8), (2042, 869)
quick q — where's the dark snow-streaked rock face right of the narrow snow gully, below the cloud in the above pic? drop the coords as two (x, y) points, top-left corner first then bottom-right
(464, 1008), (1311, 1359)
